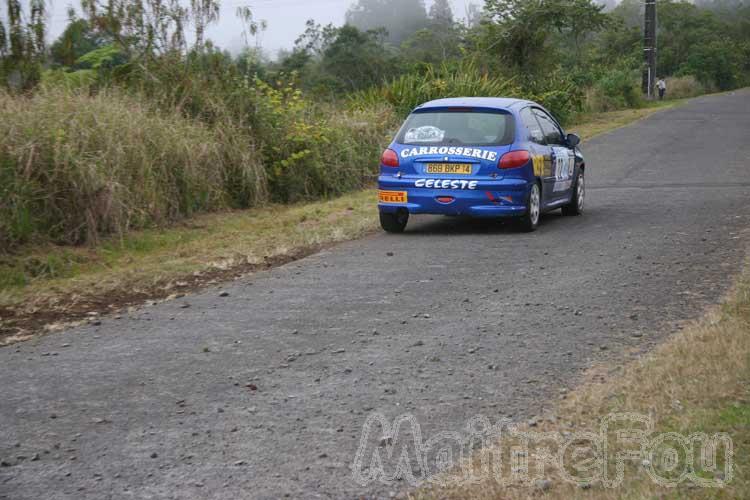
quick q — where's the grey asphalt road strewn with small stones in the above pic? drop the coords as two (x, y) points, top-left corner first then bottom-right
(0, 91), (750, 500)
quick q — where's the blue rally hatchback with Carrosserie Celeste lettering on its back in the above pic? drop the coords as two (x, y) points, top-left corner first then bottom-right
(378, 97), (585, 233)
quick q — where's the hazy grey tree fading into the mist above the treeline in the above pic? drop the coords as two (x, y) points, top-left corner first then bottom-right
(346, 0), (429, 45)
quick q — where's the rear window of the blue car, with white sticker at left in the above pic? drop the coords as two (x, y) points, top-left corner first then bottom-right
(396, 108), (515, 146)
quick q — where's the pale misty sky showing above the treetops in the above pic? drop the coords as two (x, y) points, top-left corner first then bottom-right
(49, 0), (484, 57)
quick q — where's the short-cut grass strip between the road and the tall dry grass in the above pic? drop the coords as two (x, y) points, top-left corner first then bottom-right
(0, 190), (375, 292)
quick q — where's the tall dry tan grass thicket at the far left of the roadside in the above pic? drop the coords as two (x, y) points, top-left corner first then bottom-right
(0, 89), (267, 249)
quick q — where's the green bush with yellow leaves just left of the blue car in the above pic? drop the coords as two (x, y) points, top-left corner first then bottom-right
(248, 80), (394, 202)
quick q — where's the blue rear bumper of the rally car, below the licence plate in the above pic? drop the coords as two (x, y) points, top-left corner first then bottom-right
(378, 176), (531, 217)
